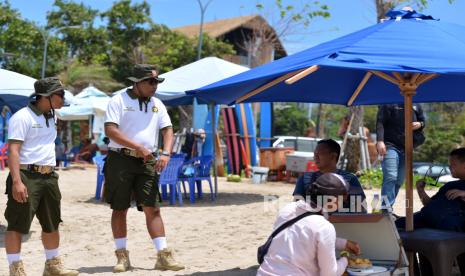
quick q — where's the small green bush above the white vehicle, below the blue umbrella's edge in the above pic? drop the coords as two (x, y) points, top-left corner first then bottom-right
(273, 103), (309, 136)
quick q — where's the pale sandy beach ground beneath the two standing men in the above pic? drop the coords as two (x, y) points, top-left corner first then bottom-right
(0, 168), (434, 275)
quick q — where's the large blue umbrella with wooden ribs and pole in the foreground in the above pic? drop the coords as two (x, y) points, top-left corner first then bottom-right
(188, 8), (465, 239)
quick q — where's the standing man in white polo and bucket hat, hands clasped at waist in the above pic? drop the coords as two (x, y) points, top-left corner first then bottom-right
(104, 64), (184, 272)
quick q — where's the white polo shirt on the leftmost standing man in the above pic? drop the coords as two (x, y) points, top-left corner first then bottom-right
(8, 104), (57, 166)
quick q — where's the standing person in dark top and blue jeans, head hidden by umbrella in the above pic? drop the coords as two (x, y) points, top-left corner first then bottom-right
(376, 104), (425, 208)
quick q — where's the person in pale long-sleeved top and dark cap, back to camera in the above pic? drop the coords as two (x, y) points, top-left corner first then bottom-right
(257, 173), (360, 276)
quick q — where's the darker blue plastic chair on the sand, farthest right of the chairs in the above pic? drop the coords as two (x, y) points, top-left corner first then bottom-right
(181, 155), (215, 203)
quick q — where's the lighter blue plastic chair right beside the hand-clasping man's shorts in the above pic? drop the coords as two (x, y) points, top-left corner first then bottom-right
(158, 154), (184, 205)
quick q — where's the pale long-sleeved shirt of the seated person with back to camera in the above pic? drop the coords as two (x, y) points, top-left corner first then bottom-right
(257, 200), (347, 276)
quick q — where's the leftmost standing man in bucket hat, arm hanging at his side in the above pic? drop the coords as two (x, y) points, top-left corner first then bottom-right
(5, 78), (79, 276)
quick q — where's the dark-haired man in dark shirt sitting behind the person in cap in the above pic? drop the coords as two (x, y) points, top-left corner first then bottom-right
(292, 139), (366, 212)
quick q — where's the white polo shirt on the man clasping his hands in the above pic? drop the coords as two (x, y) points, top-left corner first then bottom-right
(105, 91), (171, 151)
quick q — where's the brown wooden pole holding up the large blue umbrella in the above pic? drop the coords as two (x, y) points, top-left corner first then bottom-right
(399, 82), (417, 275)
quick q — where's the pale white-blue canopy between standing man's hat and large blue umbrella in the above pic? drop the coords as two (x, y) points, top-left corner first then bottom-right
(115, 57), (249, 106)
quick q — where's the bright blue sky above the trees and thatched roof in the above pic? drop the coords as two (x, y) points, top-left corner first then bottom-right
(10, 0), (465, 53)
